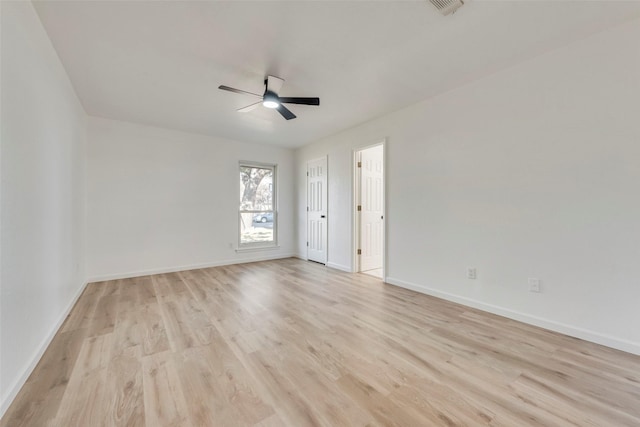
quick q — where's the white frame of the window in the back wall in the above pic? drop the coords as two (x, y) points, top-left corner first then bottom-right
(236, 160), (278, 252)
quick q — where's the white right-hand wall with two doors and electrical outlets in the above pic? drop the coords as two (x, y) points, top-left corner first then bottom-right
(296, 20), (640, 354)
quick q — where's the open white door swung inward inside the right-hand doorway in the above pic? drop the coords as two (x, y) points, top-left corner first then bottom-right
(360, 145), (384, 271)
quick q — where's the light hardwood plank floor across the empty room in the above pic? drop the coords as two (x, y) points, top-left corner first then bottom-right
(1, 259), (640, 427)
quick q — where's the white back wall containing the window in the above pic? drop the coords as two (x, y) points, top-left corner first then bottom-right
(87, 118), (295, 281)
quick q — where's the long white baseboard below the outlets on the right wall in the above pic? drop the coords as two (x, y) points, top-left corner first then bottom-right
(386, 277), (640, 355)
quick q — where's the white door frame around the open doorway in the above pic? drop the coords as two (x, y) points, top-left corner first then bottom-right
(351, 137), (387, 276)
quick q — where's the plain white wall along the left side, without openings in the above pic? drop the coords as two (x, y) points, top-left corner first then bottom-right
(0, 1), (86, 414)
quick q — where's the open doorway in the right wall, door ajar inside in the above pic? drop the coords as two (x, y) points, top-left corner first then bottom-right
(354, 143), (385, 279)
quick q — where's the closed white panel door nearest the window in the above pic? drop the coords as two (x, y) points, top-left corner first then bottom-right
(307, 157), (327, 264)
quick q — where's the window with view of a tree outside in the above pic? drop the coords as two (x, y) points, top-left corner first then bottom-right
(239, 163), (277, 248)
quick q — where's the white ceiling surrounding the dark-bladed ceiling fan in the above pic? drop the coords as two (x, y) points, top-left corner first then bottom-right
(34, 0), (640, 147)
